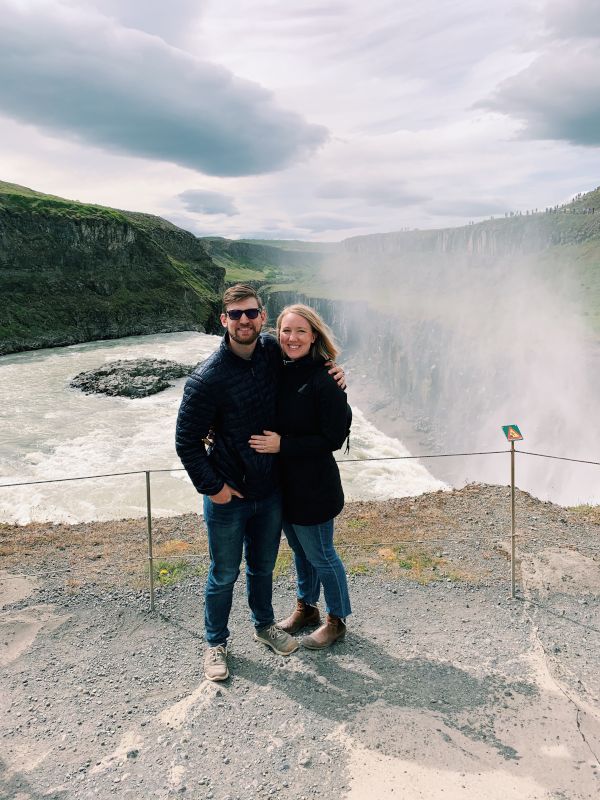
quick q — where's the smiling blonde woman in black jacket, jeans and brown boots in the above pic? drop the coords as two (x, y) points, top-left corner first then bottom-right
(250, 304), (352, 650)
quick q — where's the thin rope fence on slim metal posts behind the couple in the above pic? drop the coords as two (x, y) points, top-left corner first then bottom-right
(0, 442), (600, 611)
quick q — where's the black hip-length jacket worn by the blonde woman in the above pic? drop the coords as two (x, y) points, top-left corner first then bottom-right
(275, 355), (352, 525)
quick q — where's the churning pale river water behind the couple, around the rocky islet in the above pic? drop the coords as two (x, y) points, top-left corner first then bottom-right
(0, 333), (445, 524)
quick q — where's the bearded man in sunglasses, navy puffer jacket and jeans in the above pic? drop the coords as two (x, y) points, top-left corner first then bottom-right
(176, 284), (343, 681)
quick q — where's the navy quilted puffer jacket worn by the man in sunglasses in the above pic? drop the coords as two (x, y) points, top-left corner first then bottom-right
(175, 334), (282, 500)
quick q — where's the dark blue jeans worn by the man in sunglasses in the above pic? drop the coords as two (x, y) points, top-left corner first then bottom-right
(204, 492), (281, 647)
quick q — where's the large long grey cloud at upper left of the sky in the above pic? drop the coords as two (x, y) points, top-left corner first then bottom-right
(0, 0), (327, 176)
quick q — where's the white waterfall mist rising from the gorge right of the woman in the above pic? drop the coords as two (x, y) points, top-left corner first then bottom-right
(312, 233), (600, 504)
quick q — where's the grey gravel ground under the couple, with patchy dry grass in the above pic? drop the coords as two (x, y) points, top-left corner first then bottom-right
(0, 485), (600, 800)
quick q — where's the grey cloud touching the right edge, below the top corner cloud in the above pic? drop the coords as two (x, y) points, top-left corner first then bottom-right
(481, 41), (600, 146)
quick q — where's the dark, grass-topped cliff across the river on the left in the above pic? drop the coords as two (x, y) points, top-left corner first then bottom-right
(0, 182), (225, 354)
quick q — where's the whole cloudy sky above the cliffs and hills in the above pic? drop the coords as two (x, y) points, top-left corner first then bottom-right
(0, 0), (600, 241)
